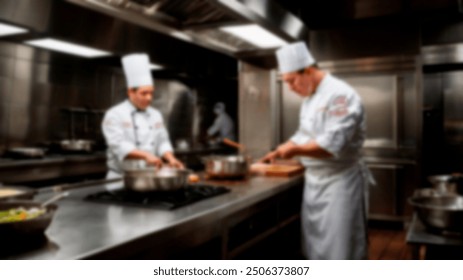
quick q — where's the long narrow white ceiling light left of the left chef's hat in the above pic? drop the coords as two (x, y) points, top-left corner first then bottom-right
(25, 38), (111, 58)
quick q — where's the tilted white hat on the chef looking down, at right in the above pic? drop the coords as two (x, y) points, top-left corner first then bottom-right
(276, 42), (315, 74)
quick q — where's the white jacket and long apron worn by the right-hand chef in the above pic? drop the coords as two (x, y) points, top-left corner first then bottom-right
(290, 73), (369, 259)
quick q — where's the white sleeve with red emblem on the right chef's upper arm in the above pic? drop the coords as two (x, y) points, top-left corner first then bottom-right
(315, 94), (363, 157)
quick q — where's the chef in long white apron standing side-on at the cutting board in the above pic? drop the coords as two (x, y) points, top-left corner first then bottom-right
(261, 42), (372, 259)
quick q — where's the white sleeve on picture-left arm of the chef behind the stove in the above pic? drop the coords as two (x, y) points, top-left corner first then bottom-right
(101, 112), (137, 161)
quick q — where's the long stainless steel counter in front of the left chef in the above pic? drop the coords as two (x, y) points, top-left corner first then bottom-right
(6, 176), (303, 259)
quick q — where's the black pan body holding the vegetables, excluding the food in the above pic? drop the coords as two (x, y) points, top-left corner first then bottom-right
(0, 200), (58, 237)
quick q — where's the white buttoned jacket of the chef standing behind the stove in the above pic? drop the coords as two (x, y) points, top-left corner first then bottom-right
(102, 100), (173, 173)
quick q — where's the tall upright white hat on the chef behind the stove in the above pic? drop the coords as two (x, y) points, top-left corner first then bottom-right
(122, 53), (154, 88)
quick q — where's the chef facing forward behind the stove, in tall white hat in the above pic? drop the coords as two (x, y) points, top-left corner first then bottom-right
(102, 54), (184, 179)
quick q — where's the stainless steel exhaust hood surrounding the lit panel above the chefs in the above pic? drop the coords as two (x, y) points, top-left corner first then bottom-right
(63, 0), (307, 58)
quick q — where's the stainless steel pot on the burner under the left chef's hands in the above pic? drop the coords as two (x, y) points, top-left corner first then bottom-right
(123, 161), (190, 192)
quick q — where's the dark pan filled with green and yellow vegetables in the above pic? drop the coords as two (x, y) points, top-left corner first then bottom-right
(0, 200), (57, 237)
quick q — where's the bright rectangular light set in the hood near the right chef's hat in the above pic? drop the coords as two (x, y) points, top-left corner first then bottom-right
(220, 24), (288, 48)
